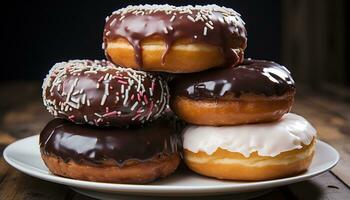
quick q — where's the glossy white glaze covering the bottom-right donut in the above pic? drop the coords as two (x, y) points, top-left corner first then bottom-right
(182, 113), (316, 157)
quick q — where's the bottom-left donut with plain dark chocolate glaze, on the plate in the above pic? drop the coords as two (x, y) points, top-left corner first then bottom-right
(40, 118), (180, 183)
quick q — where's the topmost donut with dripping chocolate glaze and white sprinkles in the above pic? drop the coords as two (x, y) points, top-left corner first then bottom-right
(102, 5), (247, 73)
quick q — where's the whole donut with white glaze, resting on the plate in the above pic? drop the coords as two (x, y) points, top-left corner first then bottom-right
(183, 113), (316, 181)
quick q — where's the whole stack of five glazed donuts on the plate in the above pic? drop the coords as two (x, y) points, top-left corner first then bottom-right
(40, 5), (316, 183)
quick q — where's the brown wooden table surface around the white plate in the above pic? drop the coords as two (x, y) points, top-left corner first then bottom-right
(0, 82), (350, 200)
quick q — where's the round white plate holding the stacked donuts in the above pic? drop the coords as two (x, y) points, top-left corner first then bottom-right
(4, 136), (339, 199)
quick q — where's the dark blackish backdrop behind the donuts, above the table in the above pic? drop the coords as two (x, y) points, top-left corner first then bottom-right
(0, 0), (350, 93)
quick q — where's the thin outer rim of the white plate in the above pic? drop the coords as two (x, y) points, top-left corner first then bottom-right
(3, 135), (340, 193)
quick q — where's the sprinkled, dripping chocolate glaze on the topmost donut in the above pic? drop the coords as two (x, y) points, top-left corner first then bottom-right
(103, 5), (247, 66)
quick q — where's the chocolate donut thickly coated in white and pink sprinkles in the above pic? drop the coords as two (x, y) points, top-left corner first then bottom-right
(42, 60), (169, 127)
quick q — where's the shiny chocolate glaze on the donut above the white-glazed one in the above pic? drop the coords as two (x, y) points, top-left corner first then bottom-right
(169, 59), (295, 99)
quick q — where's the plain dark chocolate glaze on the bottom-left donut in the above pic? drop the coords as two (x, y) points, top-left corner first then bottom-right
(40, 119), (177, 165)
